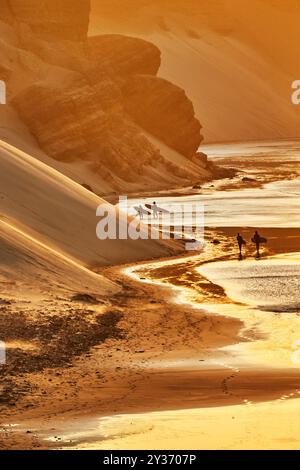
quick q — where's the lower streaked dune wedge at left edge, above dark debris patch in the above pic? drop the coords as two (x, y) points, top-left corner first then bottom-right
(0, 216), (118, 295)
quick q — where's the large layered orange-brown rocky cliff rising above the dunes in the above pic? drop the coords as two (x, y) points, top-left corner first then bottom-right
(0, 0), (208, 191)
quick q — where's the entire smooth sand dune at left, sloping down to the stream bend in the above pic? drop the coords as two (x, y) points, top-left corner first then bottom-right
(0, 141), (176, 291)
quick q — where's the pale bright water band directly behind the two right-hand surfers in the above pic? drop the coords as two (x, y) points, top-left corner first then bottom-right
(119, 178), (300, 228)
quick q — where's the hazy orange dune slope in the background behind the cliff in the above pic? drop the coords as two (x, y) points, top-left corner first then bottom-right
(90, 0), (300, 142)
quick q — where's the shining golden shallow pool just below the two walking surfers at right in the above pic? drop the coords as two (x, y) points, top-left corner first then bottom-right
(197, 253), (300, 368)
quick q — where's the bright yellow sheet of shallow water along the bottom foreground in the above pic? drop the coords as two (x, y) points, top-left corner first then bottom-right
(57, 398), (300, 450)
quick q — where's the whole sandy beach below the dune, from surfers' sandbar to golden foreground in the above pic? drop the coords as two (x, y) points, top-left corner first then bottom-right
(1, 150), (300, 449)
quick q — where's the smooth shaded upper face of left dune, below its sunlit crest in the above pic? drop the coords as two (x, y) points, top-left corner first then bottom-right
(0, 141), (173, 274)
